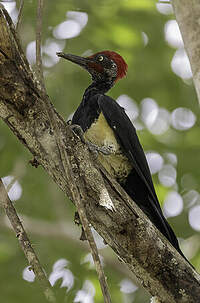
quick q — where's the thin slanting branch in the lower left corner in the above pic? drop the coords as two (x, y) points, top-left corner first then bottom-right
(0, 179), (56, 302)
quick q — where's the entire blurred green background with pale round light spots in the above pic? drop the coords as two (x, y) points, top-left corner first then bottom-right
(0, 0), (200, 303)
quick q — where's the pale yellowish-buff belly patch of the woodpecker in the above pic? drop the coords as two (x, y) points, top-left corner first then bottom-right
(85, 113), (133, 183)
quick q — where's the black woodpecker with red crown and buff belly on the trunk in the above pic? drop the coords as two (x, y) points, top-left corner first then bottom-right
(57, 51), (188, 261)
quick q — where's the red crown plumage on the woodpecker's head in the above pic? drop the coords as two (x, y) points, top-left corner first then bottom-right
(88, 50), (128, 82)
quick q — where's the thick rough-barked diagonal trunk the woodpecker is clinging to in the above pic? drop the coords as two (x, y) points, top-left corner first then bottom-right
(0, 10), (200, 303)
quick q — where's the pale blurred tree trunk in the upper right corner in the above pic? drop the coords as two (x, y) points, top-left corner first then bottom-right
(172, 0), (200, 102)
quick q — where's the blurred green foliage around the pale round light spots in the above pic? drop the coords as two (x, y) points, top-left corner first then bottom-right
(0, 0), (200, 303)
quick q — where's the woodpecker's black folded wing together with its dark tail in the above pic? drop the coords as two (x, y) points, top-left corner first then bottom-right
(98, 95), (183, 255)
